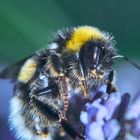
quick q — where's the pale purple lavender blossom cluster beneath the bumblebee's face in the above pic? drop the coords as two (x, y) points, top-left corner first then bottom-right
(80, 86), (140, 140)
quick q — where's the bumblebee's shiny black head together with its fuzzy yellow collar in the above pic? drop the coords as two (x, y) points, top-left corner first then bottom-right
(53, 26), (116, 77)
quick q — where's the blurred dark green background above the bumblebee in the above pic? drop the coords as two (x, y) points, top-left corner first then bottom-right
(0, 0), (140, 63)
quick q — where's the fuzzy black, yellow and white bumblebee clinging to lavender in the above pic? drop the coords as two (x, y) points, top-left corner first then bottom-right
(0, 26), (139, 140)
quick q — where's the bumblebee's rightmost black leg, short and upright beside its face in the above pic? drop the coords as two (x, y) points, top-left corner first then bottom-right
(106, 70), (117, 94)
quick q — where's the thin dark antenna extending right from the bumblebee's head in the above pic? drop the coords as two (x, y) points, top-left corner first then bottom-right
(112, 55), (140, 70)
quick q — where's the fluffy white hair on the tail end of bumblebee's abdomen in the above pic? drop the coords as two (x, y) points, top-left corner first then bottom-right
(9, 97), (52, 140)
